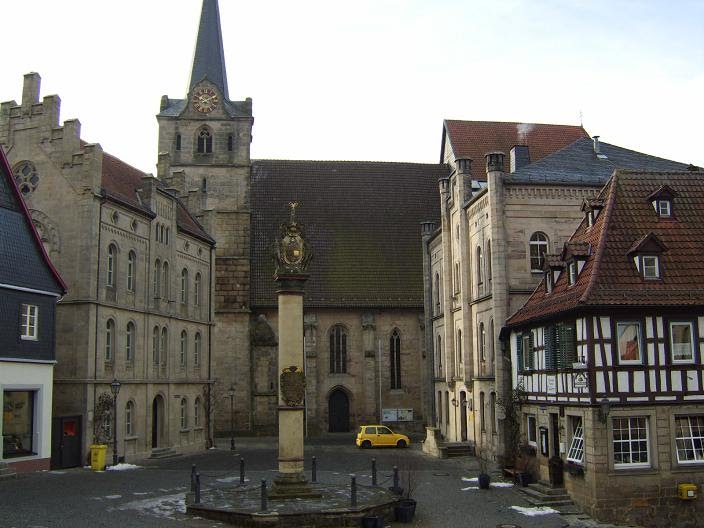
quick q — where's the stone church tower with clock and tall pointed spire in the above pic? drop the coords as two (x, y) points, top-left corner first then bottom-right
(157, 0), (253, 432)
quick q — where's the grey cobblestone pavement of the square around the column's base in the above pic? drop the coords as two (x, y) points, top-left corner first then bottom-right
(0, 434), (640, 528)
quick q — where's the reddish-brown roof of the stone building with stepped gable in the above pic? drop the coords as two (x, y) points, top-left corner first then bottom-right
(101, 152), (214, 244)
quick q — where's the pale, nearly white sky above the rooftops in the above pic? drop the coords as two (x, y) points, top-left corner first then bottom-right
(0, 0), (704, 173)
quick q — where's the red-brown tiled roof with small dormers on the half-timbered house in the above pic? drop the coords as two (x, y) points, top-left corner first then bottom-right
(507, 170), (704, 326)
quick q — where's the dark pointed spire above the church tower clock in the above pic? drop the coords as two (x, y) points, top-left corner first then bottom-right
(189, 0), (229, 99)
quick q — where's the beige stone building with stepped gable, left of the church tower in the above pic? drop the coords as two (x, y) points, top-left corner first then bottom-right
(0, 74), (213, 457)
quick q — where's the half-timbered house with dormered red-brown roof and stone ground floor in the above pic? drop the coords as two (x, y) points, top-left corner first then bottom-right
(507, 170), (704, 526)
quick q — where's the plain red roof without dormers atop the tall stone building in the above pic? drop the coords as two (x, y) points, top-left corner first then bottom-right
(440, 119), (589, 180)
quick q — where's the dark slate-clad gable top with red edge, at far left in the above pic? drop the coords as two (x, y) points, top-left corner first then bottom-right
(0, 148), (67, 295)
